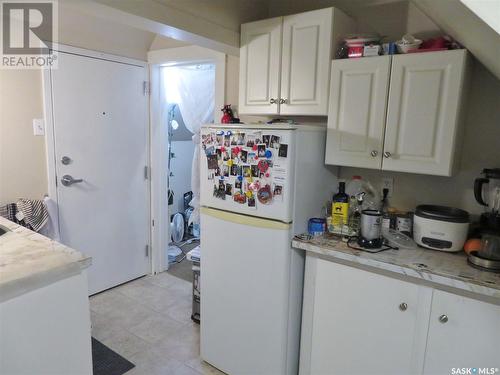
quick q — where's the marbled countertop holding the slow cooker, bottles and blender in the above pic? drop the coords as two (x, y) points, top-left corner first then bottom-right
(292, 237), (500, 303)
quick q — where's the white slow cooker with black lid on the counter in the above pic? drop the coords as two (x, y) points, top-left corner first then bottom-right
(413, 204), (469, 252)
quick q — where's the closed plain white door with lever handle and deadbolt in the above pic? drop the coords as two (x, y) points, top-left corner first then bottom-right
(51, 53), (149, 294)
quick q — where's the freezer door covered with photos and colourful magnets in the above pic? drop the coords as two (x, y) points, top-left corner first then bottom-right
(200, 127), (296, 223)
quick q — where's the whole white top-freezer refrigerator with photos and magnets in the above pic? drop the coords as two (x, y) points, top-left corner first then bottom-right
(200, 124), (337, 375)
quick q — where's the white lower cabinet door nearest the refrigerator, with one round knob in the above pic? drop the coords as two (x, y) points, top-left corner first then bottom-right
(301, 256), (431, 375)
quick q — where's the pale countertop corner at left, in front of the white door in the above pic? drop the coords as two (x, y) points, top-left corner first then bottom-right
(0, 217), (92, 302)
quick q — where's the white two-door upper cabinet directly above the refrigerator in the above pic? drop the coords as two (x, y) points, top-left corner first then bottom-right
(239, 8), (354, 116)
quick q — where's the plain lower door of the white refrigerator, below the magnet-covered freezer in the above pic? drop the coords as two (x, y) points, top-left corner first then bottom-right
(200, 209), (302, 374)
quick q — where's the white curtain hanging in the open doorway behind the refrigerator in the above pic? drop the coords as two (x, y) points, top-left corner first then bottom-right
(162, 64), (215, 224)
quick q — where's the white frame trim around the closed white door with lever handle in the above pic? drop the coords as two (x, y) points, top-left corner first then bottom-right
(42, 43), (154, 273)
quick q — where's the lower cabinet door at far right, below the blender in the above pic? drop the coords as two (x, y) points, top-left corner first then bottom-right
(424, 290), (500, 375)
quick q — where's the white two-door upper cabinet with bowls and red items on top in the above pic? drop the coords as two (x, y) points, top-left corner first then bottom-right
(325, 50), (467, 176)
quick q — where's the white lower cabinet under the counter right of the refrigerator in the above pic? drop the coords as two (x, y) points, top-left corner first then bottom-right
(300, 255), (500, 375)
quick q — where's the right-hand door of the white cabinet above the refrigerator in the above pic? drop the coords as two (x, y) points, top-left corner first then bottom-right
(280, 8), (333, 116)
